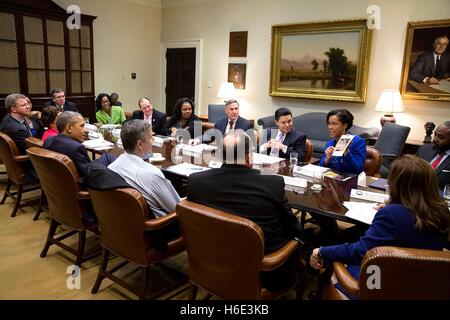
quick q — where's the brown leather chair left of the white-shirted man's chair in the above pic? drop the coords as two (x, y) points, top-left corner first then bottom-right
(27, 147), (99, 266)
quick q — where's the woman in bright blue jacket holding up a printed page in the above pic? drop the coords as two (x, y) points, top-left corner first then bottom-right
(320, 109), (366, 174)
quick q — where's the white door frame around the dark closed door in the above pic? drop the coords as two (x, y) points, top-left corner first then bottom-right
(160, 39), (203, 114)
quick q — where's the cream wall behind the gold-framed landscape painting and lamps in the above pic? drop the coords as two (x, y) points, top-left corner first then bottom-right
(162, 0), (450, 141)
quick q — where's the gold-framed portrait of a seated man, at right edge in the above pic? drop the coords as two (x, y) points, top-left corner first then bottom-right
(400, 19), (450, 101)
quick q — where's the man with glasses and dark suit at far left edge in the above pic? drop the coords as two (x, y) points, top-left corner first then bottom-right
(0, 93), (31, 154)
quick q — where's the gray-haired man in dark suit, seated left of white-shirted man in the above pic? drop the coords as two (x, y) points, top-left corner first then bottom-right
(44, 111), (115, 176)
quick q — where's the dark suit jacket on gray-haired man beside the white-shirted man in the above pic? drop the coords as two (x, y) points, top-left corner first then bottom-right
(44, 133), (91, 173)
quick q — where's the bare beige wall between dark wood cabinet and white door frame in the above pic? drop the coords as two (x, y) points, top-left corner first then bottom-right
(55, 0), (161, 111)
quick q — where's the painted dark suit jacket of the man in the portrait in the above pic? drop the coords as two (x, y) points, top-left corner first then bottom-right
(409, 52), (450, 82)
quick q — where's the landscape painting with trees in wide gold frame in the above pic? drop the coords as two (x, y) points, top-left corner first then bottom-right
(269, 19), (372, 102)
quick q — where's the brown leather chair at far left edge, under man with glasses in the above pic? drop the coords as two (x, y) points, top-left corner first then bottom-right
(0, 132), (40, 217)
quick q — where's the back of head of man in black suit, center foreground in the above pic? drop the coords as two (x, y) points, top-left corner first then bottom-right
(222, 129), (253, 164)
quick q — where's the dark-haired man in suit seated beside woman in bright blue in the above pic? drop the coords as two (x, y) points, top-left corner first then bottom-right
(260, 108), (306, 162)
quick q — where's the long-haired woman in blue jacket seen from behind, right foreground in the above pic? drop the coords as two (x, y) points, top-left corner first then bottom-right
(310, 154), (450, 298)
